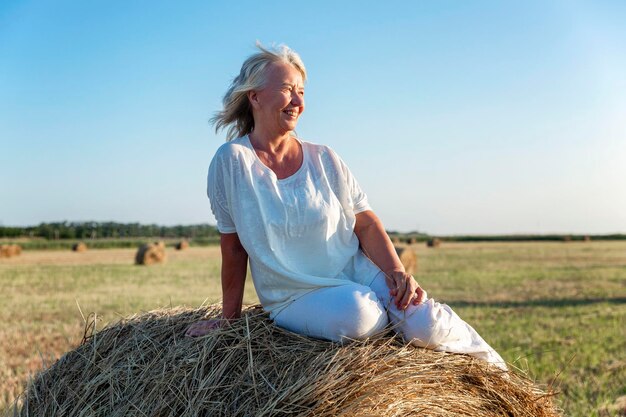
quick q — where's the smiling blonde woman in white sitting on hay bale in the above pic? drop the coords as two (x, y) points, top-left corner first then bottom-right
(187, 46), (506, 369)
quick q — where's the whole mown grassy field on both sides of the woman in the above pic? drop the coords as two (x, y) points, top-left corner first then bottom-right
(0, 242), (626, 417)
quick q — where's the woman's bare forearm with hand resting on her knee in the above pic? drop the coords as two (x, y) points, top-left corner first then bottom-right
(354, 210), (424, 310)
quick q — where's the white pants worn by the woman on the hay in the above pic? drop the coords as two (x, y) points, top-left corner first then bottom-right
(272, 272), (507, 370)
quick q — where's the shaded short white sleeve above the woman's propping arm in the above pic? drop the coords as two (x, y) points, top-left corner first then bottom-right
(207, 154), (237, 233)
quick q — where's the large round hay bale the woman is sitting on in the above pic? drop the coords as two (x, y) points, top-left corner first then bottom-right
(15, 306), (560, 417)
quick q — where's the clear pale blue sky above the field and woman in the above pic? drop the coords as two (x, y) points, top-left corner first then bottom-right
(0, 0), (626, 234)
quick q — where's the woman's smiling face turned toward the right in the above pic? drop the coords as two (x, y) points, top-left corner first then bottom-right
(248, 63), (304, 134)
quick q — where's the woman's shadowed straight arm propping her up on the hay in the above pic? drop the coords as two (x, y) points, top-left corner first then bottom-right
(185, 233), (248, 337)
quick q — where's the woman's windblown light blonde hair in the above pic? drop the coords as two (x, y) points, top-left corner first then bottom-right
(211, 41), (306, 141)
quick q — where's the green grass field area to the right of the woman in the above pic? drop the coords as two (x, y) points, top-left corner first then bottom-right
(417, 242), (626, 417)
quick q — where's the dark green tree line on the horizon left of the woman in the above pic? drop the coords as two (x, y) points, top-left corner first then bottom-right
(0, 221), (219, 240)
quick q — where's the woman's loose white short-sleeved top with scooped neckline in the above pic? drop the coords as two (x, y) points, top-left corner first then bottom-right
(207, 136), (379, 316)
